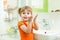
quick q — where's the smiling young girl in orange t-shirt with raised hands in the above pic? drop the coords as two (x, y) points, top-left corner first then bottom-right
(18, 6), (38, 40)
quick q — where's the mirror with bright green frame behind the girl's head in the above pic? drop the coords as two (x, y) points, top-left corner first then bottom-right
(19, 0), (48, 12)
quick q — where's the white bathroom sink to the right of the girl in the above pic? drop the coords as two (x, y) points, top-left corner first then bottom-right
(34, 30), (60, 40)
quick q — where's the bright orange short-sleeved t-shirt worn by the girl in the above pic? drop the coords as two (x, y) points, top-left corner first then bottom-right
(18, 21), (33, 40)
